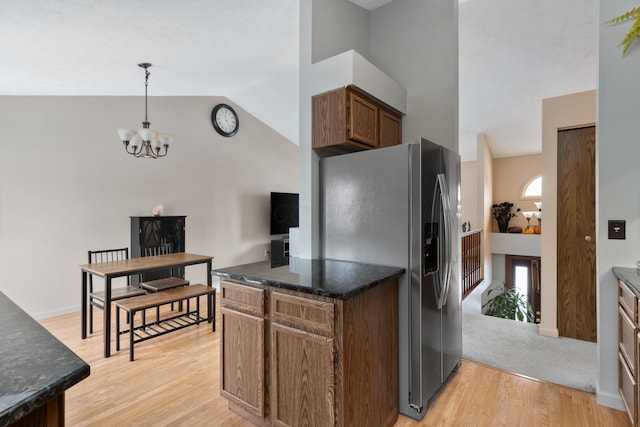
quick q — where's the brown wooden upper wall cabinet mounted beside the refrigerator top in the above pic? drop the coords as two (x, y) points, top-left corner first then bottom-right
(312, 86), (402, 157)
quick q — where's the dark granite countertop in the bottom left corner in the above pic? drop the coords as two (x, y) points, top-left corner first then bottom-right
(0, 292), (90, 425)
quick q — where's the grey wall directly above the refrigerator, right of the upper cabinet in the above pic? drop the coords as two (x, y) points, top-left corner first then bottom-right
(370, 0), (458, 153)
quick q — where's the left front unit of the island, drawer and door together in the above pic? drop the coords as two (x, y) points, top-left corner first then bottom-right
(220, 282), (265, 418)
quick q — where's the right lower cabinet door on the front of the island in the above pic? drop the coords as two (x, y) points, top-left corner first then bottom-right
(269, 323), (335, 426)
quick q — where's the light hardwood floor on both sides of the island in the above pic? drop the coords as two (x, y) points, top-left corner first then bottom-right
(41, 298), (630, 427)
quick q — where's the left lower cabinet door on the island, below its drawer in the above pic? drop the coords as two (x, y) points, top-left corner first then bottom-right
(220, 307), (265, 418)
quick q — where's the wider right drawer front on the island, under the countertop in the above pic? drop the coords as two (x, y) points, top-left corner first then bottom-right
(271, 292), (334, 335)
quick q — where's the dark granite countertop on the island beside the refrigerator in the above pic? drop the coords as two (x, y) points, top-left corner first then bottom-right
(212, 258), (404, 299)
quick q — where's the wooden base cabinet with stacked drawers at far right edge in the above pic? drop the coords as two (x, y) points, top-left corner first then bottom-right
(618, 281), (640, 425)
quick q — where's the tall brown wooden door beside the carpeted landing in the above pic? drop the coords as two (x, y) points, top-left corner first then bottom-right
(557, 126), (596, 342)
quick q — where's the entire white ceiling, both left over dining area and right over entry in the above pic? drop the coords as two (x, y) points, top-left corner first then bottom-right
(0, 0), (597, 160)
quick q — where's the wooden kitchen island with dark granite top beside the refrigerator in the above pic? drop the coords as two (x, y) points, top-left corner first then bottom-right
(213, 259), (404, 426)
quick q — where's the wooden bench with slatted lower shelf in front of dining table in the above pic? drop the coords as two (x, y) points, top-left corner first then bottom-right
(114, 284), (216, 361)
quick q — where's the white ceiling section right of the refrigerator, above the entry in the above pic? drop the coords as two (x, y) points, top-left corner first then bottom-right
(458, 0), (598, 160)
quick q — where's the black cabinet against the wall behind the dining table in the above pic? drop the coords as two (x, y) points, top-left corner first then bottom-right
(130, 216), (187, 285)
